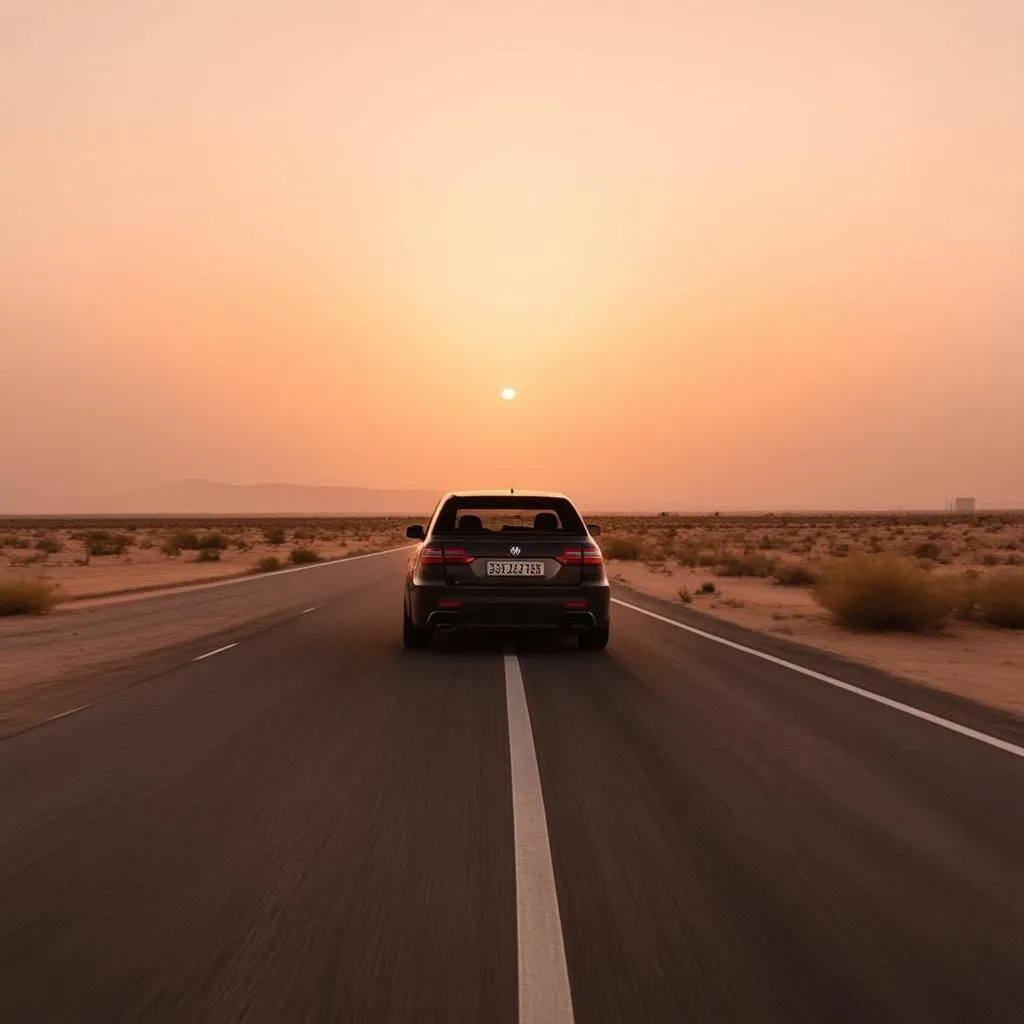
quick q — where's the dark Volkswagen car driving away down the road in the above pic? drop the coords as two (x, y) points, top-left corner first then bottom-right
(402, 489), (611, 650)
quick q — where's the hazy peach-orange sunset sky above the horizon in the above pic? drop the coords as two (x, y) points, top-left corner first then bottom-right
(0, 0), (1024, 512)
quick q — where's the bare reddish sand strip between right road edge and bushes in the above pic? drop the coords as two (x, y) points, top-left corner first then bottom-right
(608, 561), (1024, 715)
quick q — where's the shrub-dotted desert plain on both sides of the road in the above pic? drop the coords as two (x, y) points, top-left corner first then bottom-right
(0, 513), (1024, 715)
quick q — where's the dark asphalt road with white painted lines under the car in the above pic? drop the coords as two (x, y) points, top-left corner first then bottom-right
(0, 555), (1024, 1024)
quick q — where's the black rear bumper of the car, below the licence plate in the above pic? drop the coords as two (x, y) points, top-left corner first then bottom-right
(409, 584), (611, 632)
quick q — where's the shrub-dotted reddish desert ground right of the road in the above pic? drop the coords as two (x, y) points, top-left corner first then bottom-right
(600, 513), (1024, 715)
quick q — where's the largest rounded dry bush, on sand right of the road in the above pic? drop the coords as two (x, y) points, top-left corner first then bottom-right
(816, 554), (955, 633)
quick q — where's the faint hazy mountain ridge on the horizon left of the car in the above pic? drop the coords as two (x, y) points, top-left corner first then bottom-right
(91, 480), (440, 515)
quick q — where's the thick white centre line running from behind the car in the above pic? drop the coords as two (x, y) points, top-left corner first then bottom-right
(505, 646), (572, 1024)
